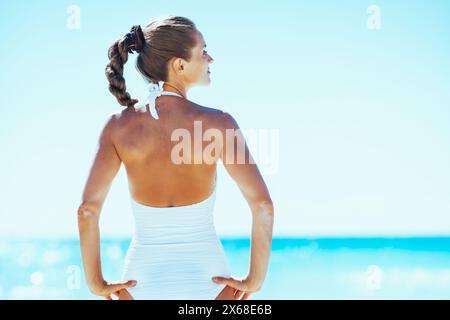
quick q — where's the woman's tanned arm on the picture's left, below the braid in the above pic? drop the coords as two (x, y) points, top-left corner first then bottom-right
(78, 116), (122, 294)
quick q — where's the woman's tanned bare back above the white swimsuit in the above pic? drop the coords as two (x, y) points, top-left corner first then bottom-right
(111, 96), (223, 207)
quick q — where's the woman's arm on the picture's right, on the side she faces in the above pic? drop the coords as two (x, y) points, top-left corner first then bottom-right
(214, 113), (274, 291)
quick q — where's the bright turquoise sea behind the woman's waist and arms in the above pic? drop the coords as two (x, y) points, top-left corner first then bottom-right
(0, 237), (450, 300)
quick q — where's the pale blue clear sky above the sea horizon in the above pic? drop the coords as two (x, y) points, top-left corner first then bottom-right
(0, 1), (450, 237)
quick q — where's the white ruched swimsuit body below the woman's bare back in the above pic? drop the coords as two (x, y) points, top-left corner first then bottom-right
(122, 175), (231, 300)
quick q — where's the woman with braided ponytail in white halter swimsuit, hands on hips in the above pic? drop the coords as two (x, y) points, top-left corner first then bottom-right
(78, 16), (274, 300)
